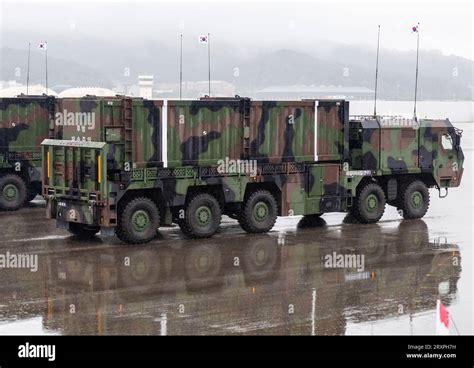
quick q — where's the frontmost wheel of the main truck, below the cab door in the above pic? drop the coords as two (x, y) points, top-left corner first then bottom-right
(398, 180), (430, 219)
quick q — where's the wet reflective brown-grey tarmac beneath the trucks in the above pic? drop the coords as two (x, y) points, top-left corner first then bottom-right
(0, 124), (474, 335)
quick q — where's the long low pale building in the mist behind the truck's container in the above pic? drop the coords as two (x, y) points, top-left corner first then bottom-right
(254, 85), (374, 100)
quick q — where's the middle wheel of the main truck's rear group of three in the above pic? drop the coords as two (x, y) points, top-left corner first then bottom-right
(178, 193), (222, 238)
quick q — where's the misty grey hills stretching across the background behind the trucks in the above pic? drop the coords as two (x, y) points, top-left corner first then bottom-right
(0, 36), (474, 100)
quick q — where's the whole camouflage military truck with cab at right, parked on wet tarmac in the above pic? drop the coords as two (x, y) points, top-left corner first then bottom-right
(42, 96), (464, 243)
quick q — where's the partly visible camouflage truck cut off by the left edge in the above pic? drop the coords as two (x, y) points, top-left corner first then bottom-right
(0, 96), (54, 211)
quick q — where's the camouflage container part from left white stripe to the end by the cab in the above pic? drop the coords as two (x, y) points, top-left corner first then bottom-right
(164, 98), (348, 167)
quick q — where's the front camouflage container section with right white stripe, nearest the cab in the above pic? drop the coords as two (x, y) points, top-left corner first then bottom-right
(250, 100), (349, 163)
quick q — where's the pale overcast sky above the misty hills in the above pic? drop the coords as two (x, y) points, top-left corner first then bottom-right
(0, 0), (474, 59)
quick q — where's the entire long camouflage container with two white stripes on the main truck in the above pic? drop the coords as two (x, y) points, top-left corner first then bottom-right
(49, 96), (348, 168)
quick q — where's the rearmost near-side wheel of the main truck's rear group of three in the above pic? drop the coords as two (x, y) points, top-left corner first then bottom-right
(115, 197), (160, 244)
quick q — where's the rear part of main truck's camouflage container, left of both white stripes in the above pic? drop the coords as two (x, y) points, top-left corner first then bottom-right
(55, 96), (163, 169)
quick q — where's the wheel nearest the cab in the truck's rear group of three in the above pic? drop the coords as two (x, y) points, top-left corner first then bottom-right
(238, 190), (278, 233)
